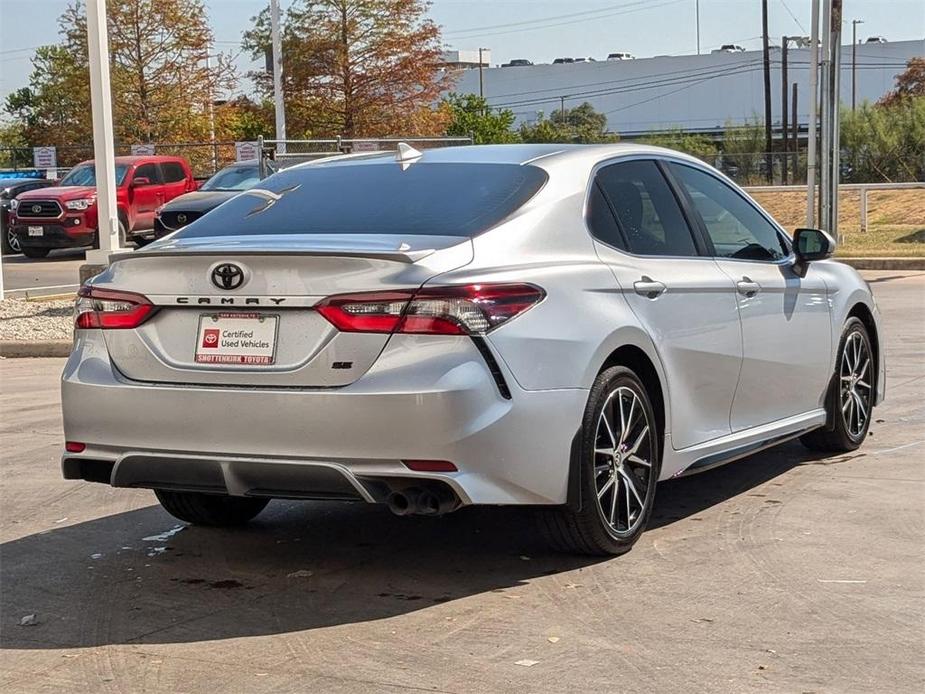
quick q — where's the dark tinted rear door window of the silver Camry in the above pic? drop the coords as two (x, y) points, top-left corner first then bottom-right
(597, 160), (698, 256)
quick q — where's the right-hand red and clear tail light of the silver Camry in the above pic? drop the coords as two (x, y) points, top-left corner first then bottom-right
(317, 284), (546, 335)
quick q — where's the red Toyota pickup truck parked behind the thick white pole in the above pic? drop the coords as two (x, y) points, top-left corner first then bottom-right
(10, 156), (196, 258)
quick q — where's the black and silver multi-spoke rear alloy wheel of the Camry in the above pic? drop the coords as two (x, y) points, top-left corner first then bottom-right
(594, 386), (653, 537)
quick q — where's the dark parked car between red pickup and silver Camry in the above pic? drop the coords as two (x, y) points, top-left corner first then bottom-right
(151, 160), (276, 239)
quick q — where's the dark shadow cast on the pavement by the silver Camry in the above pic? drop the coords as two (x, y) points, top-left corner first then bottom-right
(0, 444), (824, 649)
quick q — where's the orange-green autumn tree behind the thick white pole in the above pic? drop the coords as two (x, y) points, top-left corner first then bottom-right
(6, 0), (235, 162)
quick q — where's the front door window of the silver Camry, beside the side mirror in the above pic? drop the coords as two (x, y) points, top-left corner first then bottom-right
(671, 164), (788, 261)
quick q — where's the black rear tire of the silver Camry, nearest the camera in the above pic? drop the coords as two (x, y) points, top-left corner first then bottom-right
(538, 366), (661, 556)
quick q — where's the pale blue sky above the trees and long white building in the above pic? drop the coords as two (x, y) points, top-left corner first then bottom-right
(0, 0), (925, 100)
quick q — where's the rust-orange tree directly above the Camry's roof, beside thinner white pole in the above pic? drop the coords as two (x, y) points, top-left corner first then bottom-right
(244, 0), (450, 137)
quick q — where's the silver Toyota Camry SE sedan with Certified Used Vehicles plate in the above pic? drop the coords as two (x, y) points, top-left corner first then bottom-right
(62, 144), (884, 554)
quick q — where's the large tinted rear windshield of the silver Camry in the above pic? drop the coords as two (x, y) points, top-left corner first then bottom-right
(174, 161), (547, 238)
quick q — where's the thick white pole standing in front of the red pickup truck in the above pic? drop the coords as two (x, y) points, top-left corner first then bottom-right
(87, 0), (121, 253)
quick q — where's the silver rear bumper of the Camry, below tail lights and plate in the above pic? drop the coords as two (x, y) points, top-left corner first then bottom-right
(62, 330), (588, 504)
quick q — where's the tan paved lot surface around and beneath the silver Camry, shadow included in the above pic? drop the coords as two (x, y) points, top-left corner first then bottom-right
(0, 272), (925, 692)
